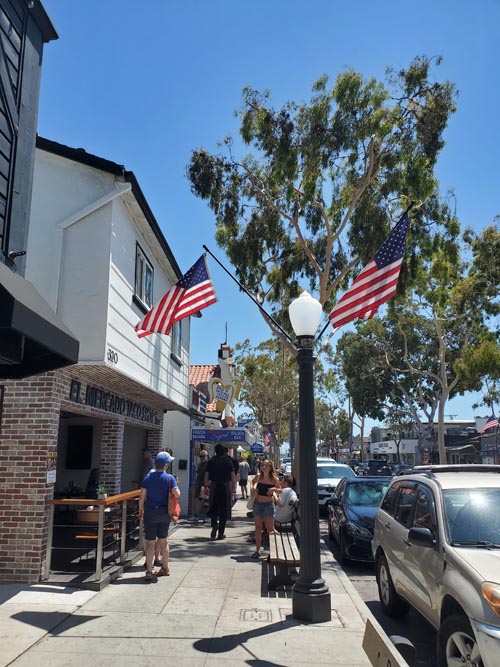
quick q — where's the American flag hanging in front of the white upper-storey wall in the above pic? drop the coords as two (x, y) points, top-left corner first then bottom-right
(135, 255), (217, 338)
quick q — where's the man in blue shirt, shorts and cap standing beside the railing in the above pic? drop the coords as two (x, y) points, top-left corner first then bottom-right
(139, 452), (181, 581)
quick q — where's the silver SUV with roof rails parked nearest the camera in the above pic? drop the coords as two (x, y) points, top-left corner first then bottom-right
(372, 465), (500, 667)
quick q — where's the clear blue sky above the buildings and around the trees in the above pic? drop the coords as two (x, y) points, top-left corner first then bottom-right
(38, 0), (500, 428)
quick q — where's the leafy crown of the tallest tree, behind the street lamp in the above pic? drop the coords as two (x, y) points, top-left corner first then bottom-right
(187, 57), (455, 342)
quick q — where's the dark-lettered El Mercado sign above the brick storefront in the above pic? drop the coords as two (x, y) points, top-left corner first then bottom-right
(69, 380), (161, 425)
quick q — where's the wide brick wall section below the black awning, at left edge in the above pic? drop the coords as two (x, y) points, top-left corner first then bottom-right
(0, 373), (60, 583)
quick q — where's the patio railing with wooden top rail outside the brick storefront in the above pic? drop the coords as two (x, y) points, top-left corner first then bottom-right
(44, 489), (143, 581)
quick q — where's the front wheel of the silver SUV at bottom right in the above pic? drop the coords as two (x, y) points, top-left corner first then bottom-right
(438, 614), (484, 667)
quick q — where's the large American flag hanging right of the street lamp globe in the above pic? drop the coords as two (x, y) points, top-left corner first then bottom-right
(328, 213), (409, 329)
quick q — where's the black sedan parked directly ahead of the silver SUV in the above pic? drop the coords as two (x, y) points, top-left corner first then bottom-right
(327, 477), (392, 561)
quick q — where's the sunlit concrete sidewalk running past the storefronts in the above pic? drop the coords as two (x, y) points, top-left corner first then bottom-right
(0, 500), (403, 667)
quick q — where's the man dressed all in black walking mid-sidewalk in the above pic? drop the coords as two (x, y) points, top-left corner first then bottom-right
(205, 444), (236, 540)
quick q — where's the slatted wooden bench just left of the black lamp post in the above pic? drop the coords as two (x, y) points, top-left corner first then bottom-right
(267, 502), (300, 591)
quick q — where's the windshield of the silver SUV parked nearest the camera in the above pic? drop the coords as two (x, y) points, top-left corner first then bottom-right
(443, 488), (500, 547)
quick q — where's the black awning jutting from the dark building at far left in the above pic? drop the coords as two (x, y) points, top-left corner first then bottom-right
(0, 262), (80, 379)
